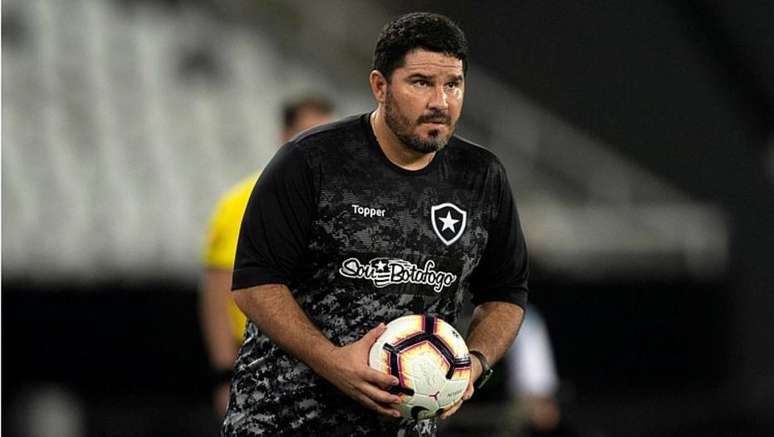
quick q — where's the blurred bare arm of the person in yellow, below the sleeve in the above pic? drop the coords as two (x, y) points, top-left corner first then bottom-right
(199, 268), (237, 416)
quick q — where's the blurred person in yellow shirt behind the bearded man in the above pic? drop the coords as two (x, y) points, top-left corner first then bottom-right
(199, 95), (333, 417)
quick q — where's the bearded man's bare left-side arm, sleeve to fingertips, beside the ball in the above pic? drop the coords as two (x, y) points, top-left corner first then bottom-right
(234, 284), (400, 417)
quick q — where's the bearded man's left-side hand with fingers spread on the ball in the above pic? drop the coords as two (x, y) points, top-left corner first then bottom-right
(321, 323), (400, 417)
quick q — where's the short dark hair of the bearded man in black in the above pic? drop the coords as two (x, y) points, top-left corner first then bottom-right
(373, 12), (468, 81)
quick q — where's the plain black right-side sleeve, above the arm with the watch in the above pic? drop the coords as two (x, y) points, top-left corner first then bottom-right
(470, 163), (529, 308)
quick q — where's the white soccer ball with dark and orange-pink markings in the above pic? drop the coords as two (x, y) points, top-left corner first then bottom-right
(368, 315), (470, 420)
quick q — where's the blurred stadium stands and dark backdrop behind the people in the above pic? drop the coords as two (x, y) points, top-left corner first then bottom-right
(2, 0), (774, 437)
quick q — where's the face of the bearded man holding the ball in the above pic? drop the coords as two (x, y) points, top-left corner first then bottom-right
(384, 49), (465, 153)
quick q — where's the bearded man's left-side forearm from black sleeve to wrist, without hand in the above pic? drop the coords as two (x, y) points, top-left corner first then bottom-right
(234, 284), (336, 375)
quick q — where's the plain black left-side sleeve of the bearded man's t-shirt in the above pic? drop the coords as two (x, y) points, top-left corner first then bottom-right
(231, 143), (316, 290)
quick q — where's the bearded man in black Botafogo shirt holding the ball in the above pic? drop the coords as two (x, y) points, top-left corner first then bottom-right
(223, 13), (527, 436)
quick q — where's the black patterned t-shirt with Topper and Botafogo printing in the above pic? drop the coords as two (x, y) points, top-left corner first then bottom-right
(224, 114), (528, 436)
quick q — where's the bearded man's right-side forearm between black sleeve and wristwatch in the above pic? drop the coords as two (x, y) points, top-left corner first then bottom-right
(467, 302), (524, 365)
